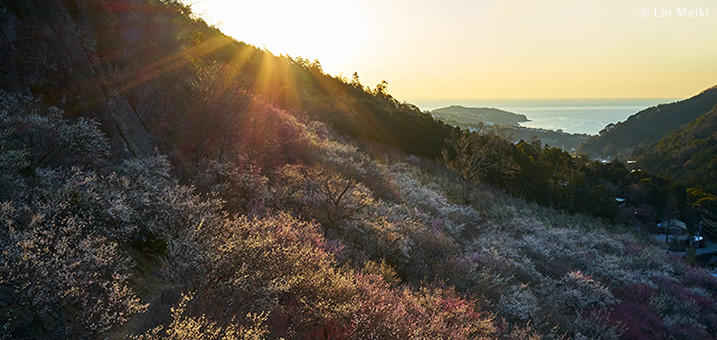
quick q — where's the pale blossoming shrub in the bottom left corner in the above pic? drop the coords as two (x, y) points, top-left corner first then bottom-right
(0, 214), (146, 337)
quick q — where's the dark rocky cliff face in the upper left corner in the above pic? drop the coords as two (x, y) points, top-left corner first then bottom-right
(0, 0), (154, 156)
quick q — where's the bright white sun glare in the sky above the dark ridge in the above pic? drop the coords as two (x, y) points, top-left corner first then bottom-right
(190, 0), (365, 72)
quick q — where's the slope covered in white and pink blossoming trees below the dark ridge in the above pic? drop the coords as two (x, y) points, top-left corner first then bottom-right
(8, 94), (717, 339)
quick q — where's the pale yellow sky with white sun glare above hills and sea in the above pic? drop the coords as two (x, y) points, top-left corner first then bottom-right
(185, 0), (717, 102)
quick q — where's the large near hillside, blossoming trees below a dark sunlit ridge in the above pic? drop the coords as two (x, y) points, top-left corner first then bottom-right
(0, 0), (717, 339)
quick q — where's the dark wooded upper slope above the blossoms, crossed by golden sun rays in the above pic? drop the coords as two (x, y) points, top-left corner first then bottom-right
(0, 0), (454, 172)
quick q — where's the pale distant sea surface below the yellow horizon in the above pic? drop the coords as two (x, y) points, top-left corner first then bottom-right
(411, 98), (680, 135)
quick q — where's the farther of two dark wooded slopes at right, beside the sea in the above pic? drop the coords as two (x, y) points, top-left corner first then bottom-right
(578, 87), (717, 158)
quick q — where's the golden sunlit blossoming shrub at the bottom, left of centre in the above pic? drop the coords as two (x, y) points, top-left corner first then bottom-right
(164, 213), (354, 336)
